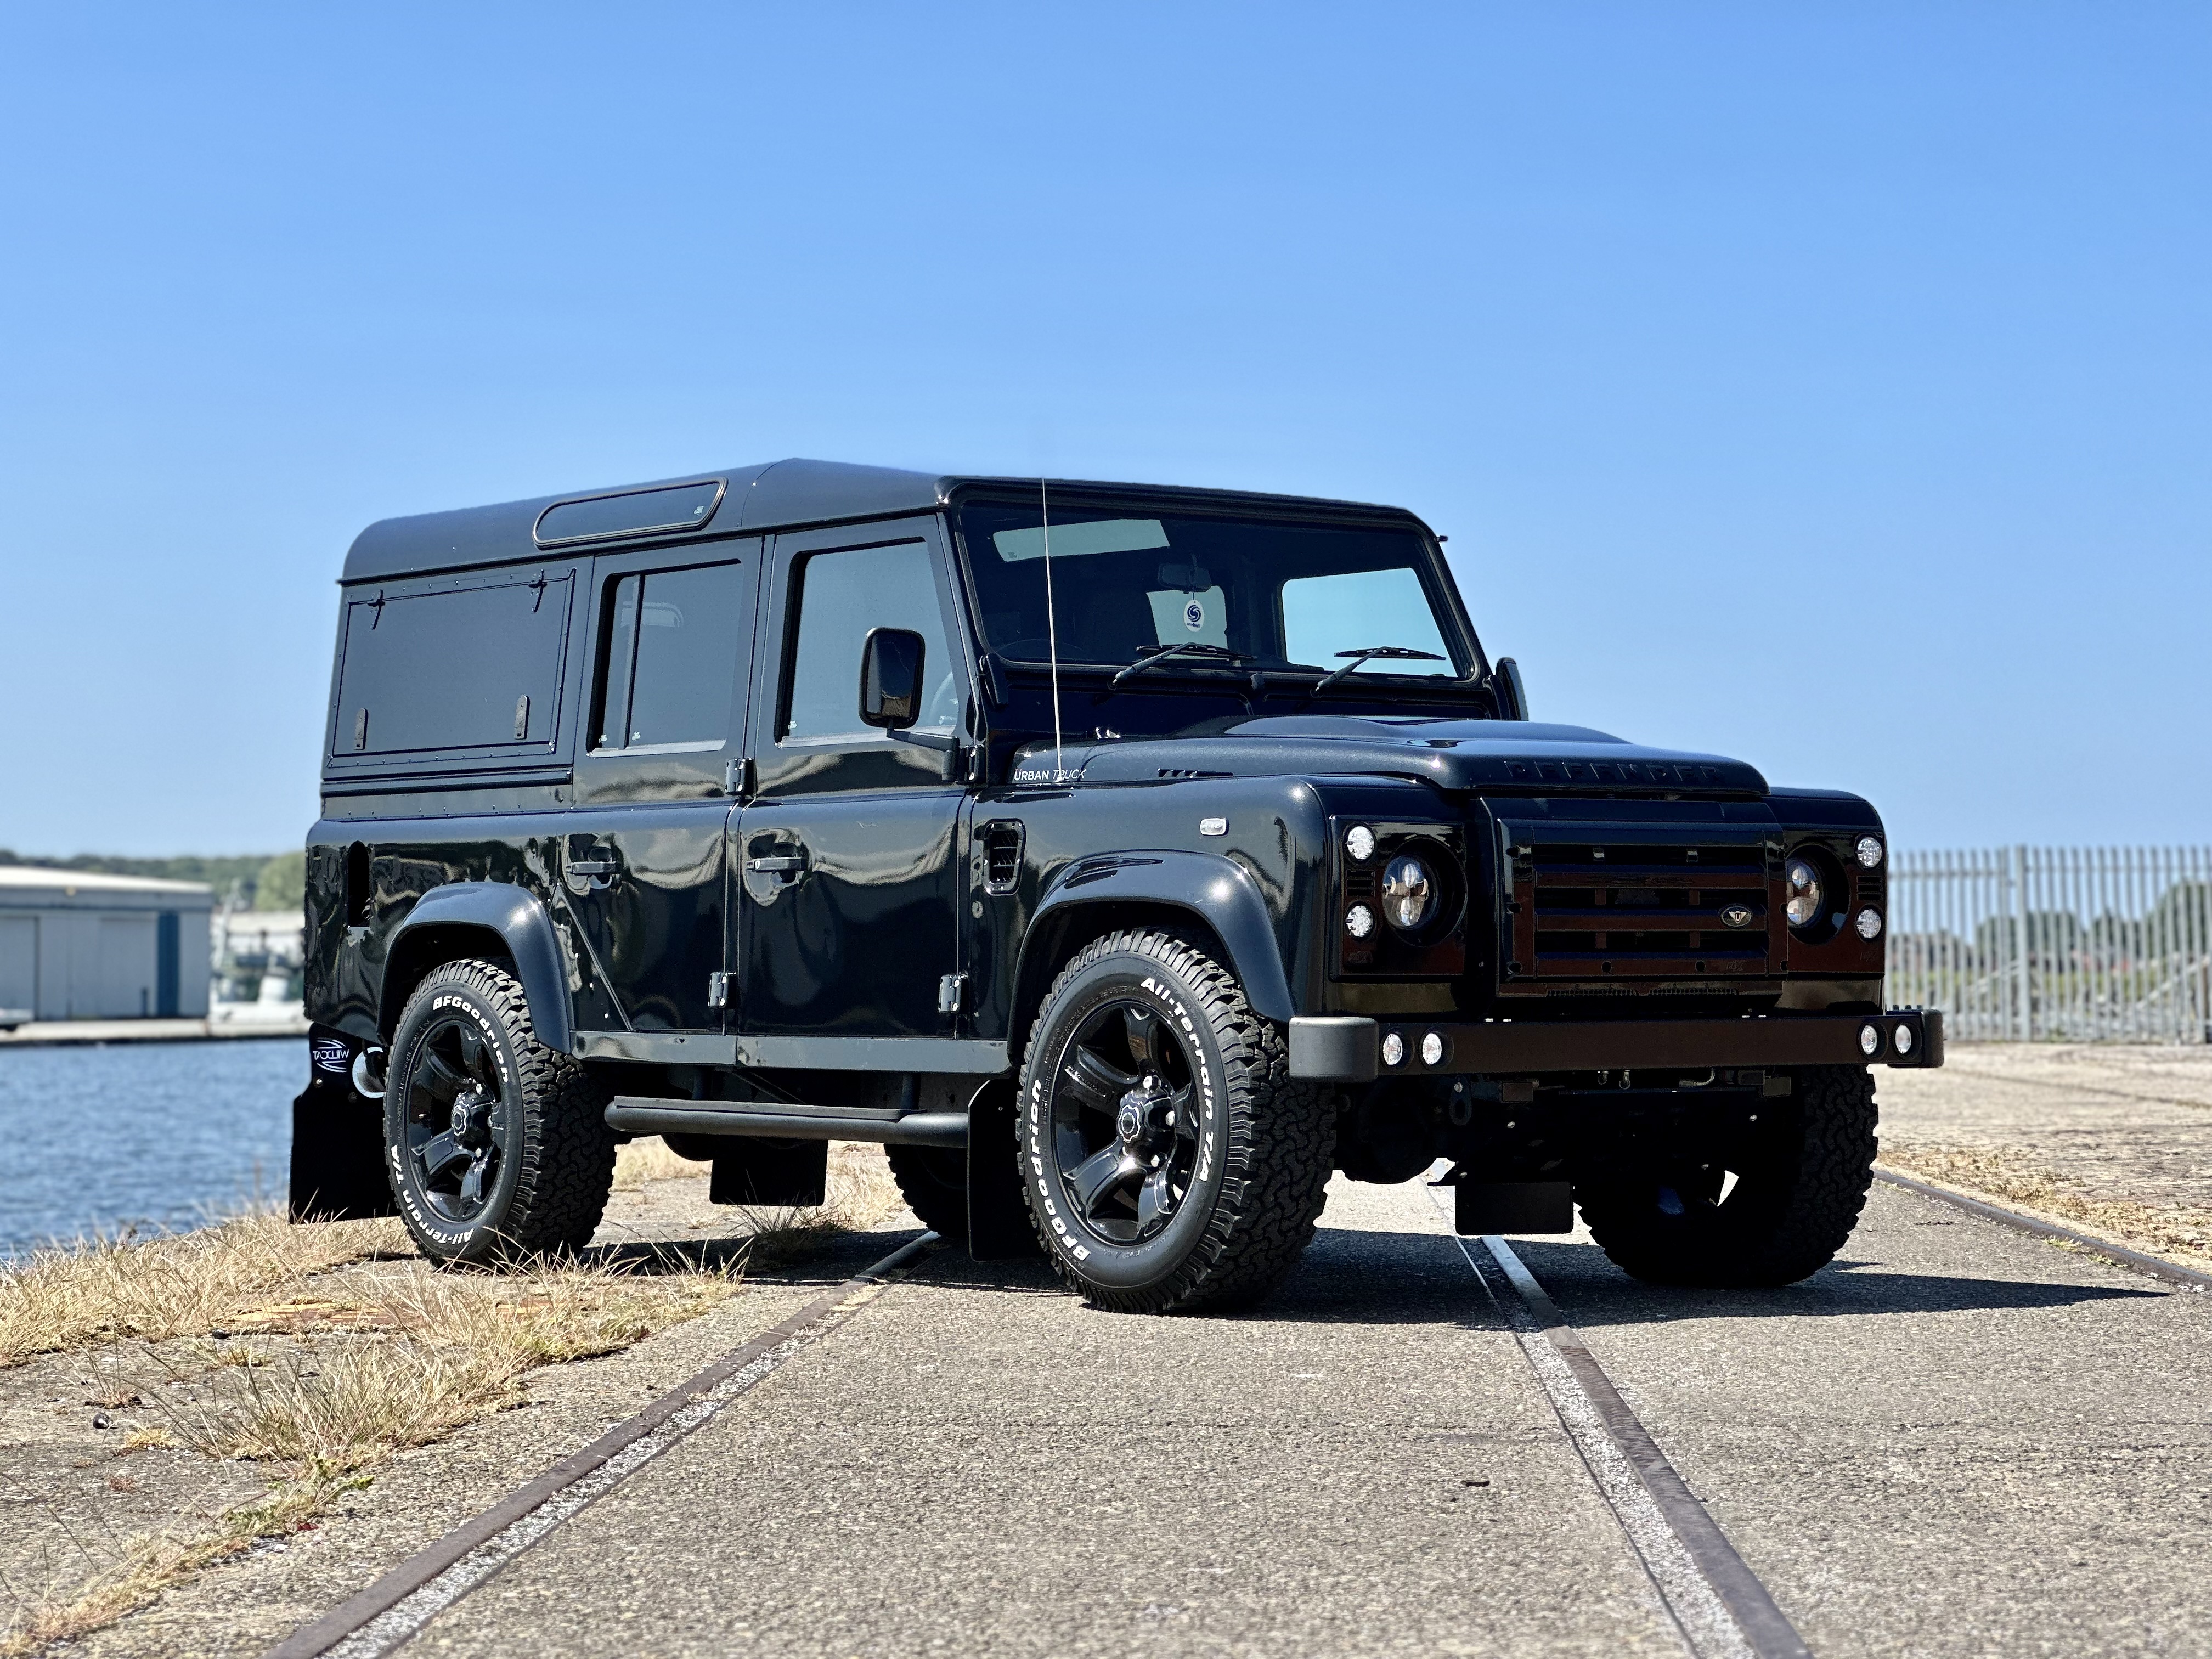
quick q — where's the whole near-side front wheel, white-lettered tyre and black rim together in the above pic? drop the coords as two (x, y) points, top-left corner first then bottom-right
(1015, 931), (1334, 1314)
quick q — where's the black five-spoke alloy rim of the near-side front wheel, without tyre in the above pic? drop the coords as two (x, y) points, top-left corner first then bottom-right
(1051, 997), (1199, 1245)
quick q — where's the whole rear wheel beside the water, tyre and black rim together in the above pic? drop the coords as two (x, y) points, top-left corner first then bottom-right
(385, 960), (615, 1263)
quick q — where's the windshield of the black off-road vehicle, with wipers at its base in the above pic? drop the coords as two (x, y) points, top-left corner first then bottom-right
(960, 502), (1471, 679)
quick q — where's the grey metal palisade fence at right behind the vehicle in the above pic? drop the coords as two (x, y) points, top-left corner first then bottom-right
(1887, 847), (2212, 1042)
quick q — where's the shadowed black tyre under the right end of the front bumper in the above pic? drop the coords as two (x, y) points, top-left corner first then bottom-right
(1575, 1066), (1876, 1288)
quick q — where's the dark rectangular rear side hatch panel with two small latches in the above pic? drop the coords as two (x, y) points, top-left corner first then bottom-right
(332, 571), (575, 757)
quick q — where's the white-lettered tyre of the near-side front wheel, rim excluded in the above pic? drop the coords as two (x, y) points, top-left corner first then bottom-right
(1015, 929), (1336, 1314)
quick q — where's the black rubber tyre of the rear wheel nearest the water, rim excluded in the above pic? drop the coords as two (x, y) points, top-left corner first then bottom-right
(385, 960), (615, 1265)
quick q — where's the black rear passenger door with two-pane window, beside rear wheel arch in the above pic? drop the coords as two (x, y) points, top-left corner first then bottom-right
(553, 540), (761, 1031)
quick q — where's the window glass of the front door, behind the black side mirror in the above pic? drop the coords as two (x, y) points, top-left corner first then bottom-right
(776, 542), (960, 741)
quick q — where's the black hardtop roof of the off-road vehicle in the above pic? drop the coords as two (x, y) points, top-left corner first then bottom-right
(341, 460), (1411, 582)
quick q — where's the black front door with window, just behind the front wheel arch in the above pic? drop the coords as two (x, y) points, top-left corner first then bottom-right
(732, 520), (969, 1037)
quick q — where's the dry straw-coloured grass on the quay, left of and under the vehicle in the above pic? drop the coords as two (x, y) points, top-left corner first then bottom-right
(0, 1139), (900, 1657)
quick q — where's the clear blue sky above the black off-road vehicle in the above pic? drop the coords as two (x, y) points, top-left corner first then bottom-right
(0, 0), (2212, 854)
